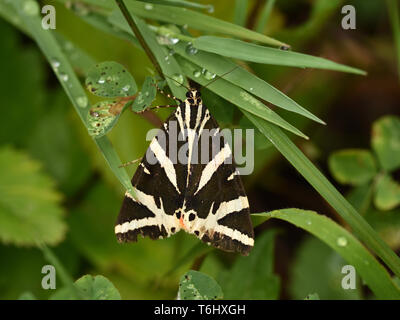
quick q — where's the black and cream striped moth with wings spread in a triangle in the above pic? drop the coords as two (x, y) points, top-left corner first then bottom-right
(115, 88), (254, 255)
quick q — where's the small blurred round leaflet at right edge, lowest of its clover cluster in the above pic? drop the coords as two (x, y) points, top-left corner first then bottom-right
(374, 174), (400, 211)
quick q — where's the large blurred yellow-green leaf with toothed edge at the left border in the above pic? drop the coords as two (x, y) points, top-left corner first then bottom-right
(0, 147), (66, 246)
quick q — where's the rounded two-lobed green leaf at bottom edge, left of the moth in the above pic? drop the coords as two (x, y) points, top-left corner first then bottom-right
(50, 275), (121, 300)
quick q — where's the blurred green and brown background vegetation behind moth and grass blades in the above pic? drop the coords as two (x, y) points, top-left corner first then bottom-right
(0, 0), (400, 299)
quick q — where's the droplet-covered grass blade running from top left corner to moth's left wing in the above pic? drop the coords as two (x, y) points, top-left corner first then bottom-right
(13, 0), (134, 196)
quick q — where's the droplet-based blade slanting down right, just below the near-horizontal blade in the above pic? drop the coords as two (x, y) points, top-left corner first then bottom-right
(173, 42), (324, 123)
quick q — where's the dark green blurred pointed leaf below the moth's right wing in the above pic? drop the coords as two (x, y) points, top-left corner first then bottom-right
(218, 230), (280, 300)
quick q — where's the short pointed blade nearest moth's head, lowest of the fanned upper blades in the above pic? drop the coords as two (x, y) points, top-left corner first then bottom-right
(176, 56), (308, 139)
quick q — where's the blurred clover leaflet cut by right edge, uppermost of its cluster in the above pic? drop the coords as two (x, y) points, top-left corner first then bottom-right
(371, 116), (400, 171)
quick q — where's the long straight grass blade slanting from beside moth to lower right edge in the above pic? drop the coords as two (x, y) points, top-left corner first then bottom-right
(243, 111), (400, 276)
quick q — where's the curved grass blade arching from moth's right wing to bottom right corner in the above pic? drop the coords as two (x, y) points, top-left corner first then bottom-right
(252, 209), (400, 299)
